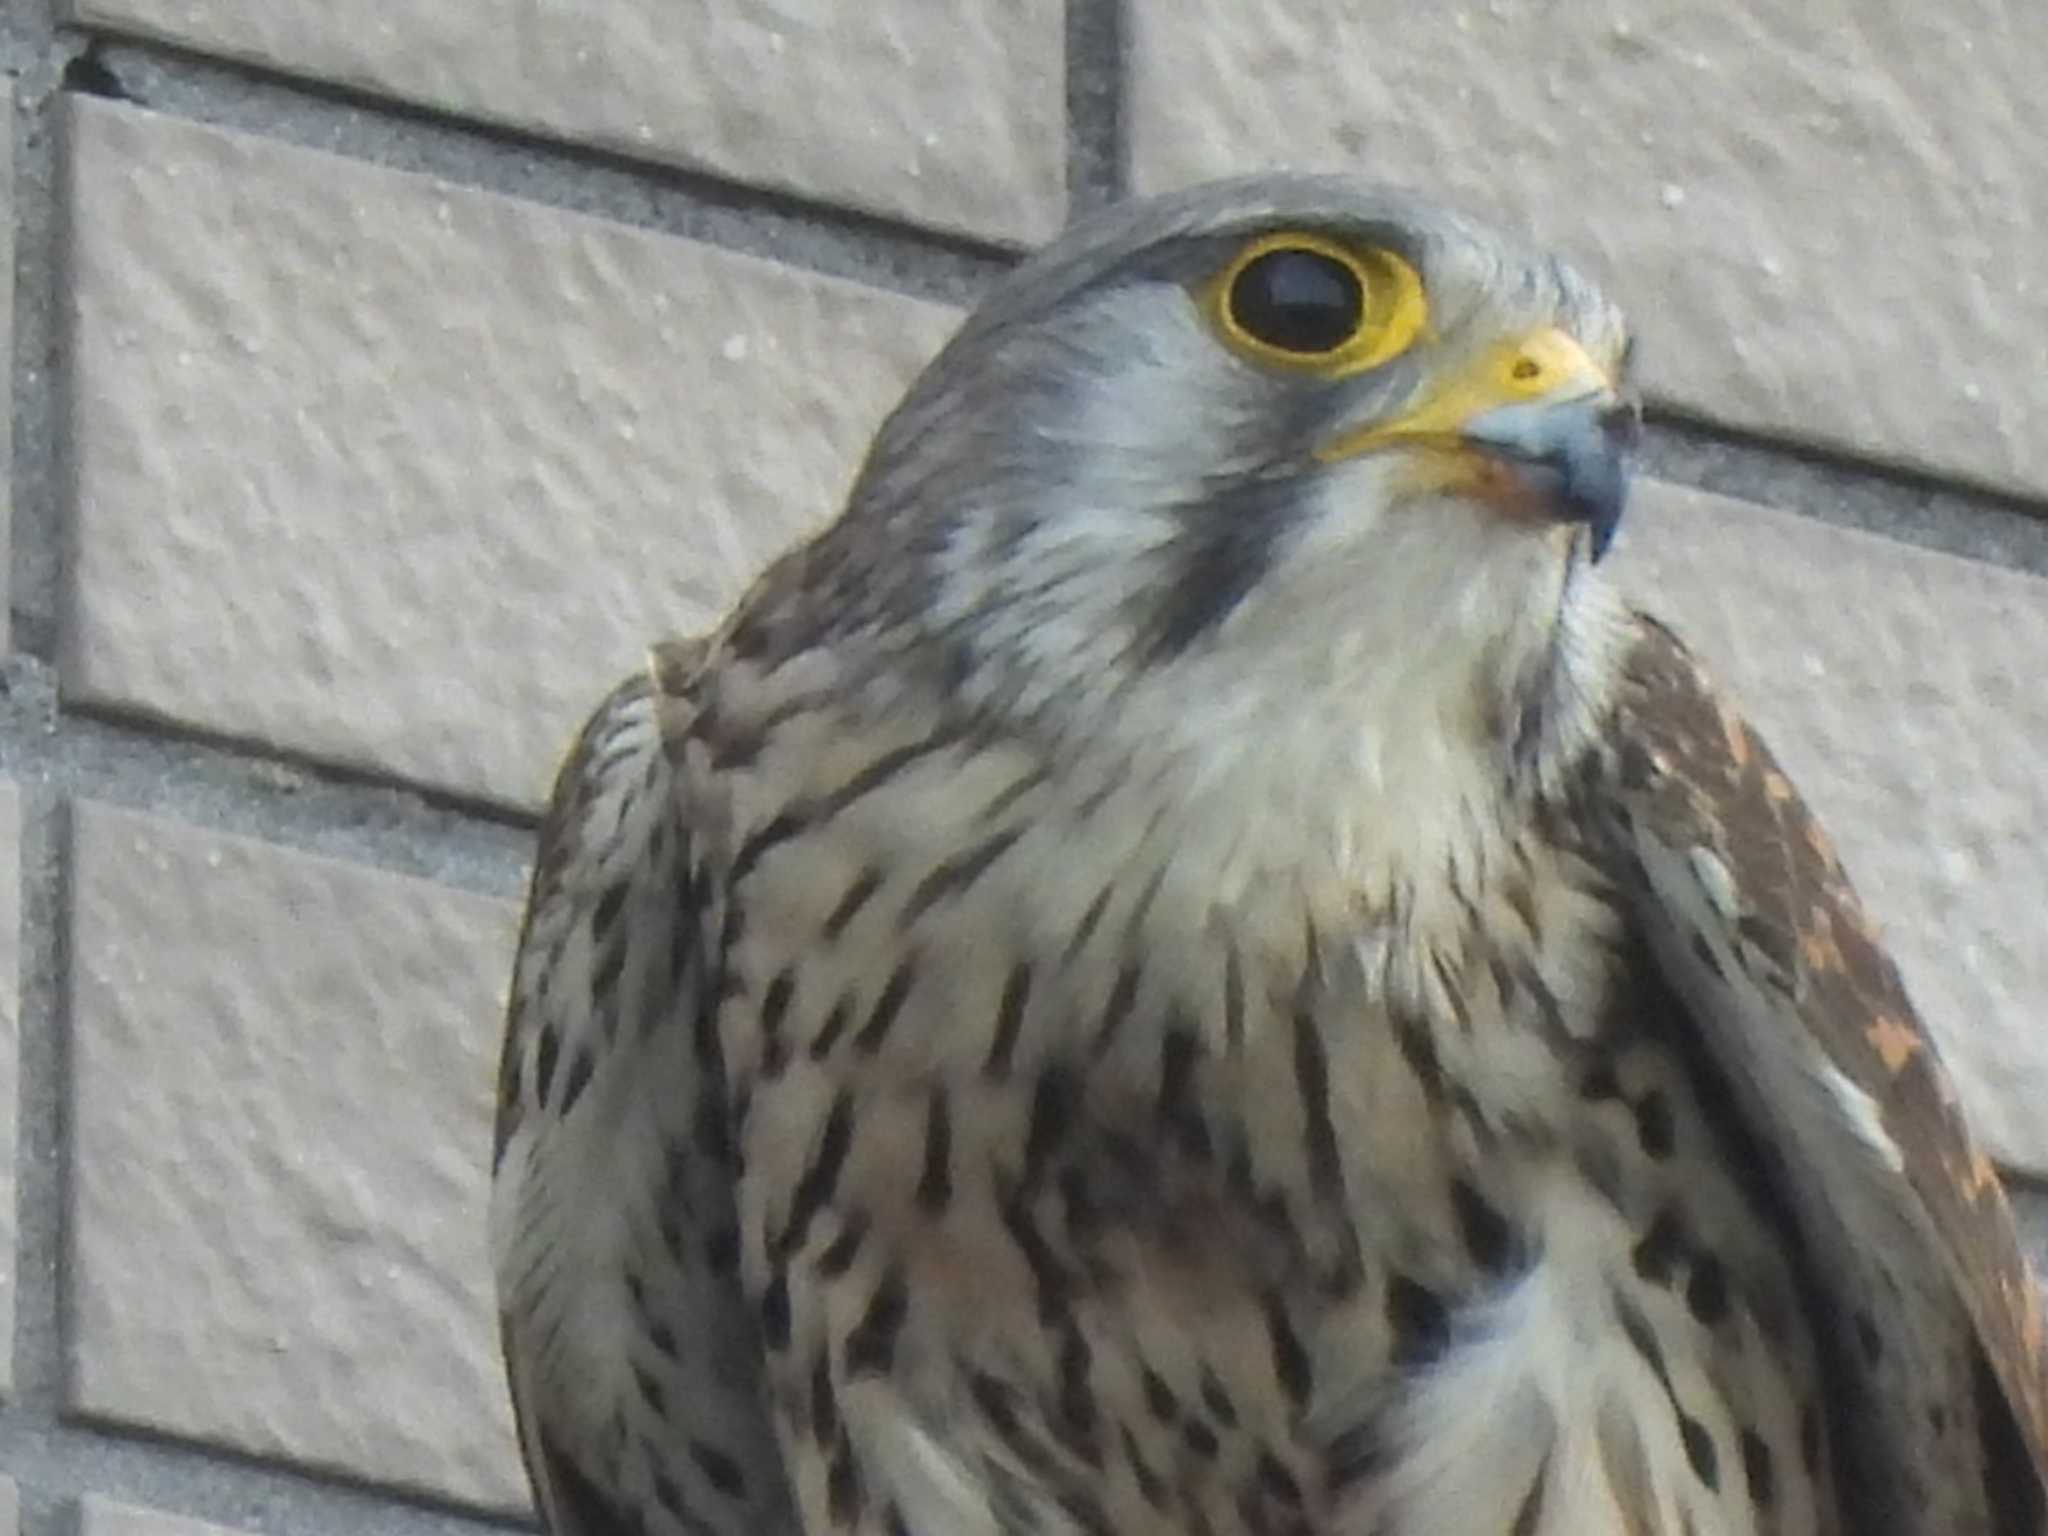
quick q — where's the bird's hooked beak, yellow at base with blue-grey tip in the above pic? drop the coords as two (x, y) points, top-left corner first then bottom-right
(1317, 328), (1642, 561)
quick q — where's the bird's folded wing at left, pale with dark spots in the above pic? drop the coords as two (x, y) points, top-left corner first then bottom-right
(492, 643), (795, 1536)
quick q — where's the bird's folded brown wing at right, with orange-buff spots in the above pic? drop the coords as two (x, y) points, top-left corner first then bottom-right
(1604, 618), (2048, 1536)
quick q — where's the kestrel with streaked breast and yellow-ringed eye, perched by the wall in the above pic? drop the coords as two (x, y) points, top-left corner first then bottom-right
(494, 178), (2048, 1536)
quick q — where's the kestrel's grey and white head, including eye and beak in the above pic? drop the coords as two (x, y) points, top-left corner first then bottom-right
(786, 176), (1636, 819)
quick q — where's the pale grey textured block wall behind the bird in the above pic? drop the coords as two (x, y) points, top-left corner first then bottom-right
(0, 0), (2048, 1536)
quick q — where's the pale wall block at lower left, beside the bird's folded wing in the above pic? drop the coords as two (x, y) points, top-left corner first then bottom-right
(68, 801), (524, 1509)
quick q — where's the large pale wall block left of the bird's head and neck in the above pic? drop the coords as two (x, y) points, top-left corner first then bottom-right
(61, 100), (954, 803)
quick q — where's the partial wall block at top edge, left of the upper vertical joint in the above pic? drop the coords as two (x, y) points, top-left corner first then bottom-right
(74, 0), (1065, 240)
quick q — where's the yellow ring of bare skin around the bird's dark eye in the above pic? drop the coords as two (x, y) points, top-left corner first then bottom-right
(1202, 231), (1430, 379)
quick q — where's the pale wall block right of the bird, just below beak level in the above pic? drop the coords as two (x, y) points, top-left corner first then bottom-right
(1616, 483), (2048, 1174)
